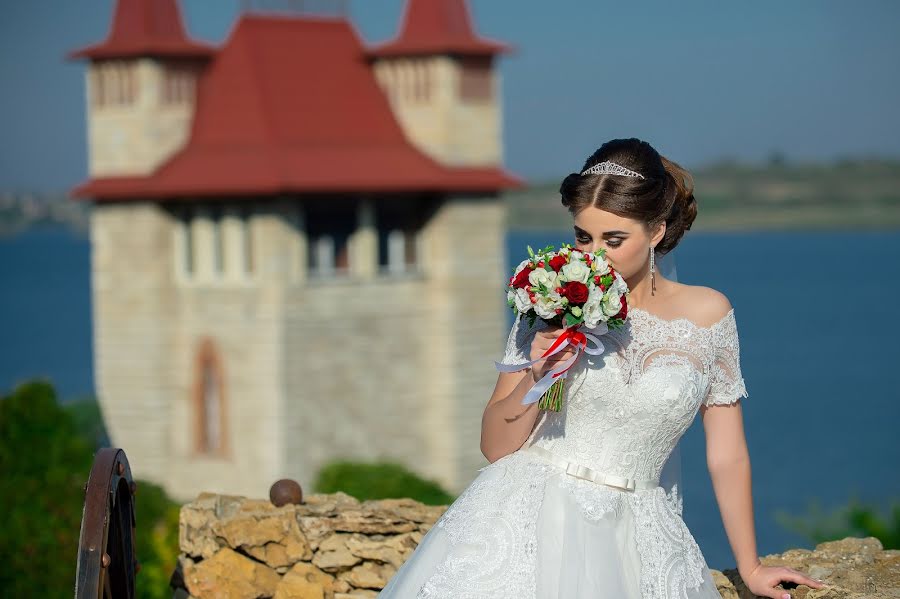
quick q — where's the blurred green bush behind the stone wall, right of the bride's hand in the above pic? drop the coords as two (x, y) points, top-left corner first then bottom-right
(775, 497), (900, 549)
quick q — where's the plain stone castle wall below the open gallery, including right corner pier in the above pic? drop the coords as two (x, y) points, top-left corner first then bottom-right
(283, 198), (505, 492)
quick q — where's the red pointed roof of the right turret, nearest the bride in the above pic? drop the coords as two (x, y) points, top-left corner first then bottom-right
(370, 0), (510, 57)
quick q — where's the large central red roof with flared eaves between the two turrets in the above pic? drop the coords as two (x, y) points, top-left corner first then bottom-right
(74, 15), (522, 200)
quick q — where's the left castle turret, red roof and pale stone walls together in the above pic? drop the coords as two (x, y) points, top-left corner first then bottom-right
(69, 0), (215, 177)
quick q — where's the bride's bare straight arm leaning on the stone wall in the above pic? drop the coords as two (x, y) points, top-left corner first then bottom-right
(700, 401), (824, 599)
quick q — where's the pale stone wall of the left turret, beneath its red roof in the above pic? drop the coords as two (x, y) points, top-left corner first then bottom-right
(86, 58), (195, 177)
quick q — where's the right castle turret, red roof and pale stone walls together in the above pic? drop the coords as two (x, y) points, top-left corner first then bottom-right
(370, 0), (509, 166)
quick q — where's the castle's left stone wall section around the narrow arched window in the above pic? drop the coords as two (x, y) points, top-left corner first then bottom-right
(91, 202), (292, 500)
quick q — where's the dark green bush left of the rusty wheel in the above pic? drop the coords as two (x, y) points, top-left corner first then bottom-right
(0, 382), (93, 598)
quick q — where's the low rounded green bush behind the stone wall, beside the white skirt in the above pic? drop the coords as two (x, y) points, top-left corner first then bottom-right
(313, 461), (455, 505)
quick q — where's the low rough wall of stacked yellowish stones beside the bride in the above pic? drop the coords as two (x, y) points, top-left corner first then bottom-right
(172, 493), (900, 599)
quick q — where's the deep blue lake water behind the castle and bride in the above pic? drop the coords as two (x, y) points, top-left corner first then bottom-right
(0, 229), (900, 568)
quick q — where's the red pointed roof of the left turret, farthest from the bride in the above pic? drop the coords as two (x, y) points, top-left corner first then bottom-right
(69, 0), (216, 60)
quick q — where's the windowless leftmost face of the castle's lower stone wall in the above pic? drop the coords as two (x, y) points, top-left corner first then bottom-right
(91, 204), (178, 490)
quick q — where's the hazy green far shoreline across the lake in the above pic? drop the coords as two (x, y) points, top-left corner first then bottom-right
(0, 160), (900, 239)
